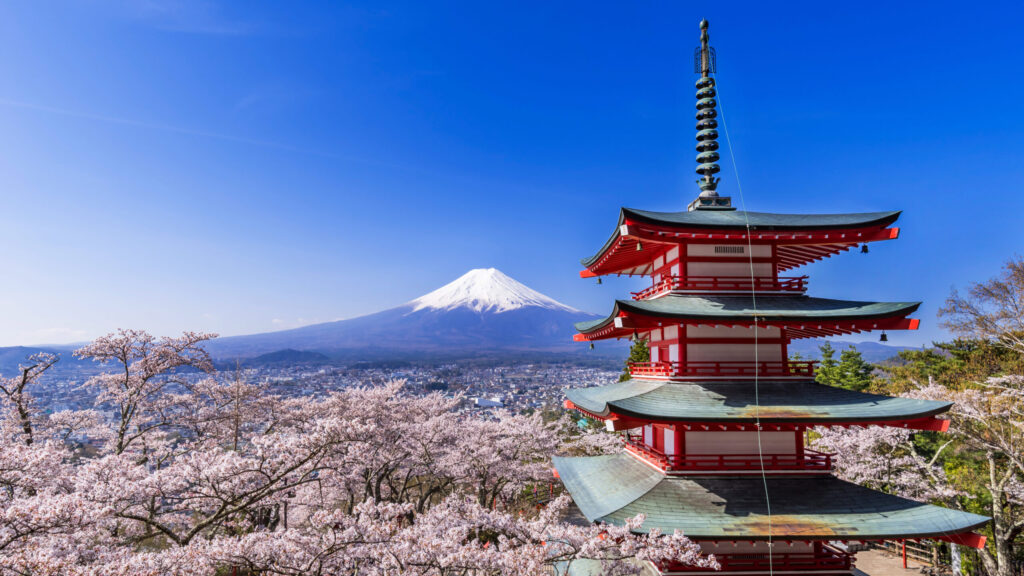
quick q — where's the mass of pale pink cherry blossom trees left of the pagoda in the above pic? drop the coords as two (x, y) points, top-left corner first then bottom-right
(0, 330), (717, 576)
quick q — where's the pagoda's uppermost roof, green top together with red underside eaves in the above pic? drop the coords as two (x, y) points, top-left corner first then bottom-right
(581, 208), (900, 277)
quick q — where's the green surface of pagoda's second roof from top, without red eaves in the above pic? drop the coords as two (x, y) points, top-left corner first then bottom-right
(575, 294), (921, 332)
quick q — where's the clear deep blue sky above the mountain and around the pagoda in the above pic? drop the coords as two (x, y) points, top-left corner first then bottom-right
(0, 0), (1024, 345)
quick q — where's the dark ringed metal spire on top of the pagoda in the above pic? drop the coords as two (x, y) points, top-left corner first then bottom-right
(687, 19), (735, 210)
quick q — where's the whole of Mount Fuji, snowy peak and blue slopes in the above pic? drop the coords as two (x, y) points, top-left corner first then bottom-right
(207, 269), (597, 359)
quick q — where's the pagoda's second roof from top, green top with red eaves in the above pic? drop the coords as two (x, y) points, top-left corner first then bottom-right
(575, 294), (921, 340)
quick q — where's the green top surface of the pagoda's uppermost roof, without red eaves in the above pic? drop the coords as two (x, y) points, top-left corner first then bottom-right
(582, 208), (900, 266)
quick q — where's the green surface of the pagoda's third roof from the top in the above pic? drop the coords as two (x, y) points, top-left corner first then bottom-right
(565, 379), (952, 423)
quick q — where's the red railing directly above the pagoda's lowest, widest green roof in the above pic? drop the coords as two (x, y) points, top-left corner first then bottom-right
(626, 435), (834, 472)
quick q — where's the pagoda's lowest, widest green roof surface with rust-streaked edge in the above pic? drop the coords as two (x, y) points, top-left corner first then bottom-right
(554, 453), (989, 540)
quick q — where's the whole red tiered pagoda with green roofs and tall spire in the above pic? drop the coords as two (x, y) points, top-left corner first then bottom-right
(554, 20), (988, 575)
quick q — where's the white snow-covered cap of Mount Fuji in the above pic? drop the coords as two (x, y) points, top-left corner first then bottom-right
(409, 268), (580, 313)
